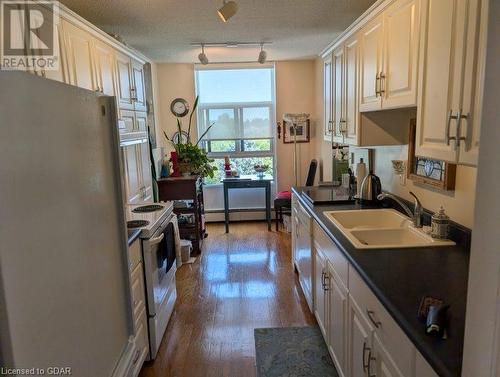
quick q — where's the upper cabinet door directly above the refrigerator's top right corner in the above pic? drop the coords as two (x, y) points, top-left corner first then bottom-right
(93, 41), (116, 96)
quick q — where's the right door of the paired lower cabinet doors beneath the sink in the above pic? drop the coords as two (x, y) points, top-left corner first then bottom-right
(326, 262), (348, 377)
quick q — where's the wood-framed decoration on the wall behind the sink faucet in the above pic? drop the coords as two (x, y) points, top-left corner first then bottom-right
(408, 119), (457, 191)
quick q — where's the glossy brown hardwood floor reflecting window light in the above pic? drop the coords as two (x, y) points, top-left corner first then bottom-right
(140, 222), (316, 377)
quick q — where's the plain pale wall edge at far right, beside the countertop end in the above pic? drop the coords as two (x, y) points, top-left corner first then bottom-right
(462, 1), (500, 377)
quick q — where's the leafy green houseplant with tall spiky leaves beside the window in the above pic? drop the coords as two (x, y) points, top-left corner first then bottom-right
(163, 97), (217, 178)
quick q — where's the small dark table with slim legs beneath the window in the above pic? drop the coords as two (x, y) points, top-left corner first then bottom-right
(222, 175), (273, 233)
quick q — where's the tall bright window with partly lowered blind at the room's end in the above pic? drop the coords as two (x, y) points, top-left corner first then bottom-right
(195, 66), (275, 184)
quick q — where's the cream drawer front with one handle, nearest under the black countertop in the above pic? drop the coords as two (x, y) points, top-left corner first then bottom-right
(349, 266), (414, 376)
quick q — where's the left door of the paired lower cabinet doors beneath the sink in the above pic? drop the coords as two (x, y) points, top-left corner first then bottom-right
(314, 247), (328, 339)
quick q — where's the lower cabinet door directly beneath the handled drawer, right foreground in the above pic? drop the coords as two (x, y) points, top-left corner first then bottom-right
(347, 294), (373, 377)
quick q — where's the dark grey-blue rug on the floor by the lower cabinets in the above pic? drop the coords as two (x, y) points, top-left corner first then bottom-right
(254, 326), (338, 377)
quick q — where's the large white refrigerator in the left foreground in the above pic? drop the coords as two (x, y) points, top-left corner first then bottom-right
(0, 72), (135, 377)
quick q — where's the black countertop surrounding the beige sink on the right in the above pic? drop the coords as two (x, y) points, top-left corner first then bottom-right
(292, 187), (470, 377)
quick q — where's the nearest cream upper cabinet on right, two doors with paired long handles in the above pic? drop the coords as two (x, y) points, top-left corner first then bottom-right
(415, 0), (487, 165)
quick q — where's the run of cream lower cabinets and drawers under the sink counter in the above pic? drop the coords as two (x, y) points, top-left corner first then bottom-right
(304, 221), (437, 377)
